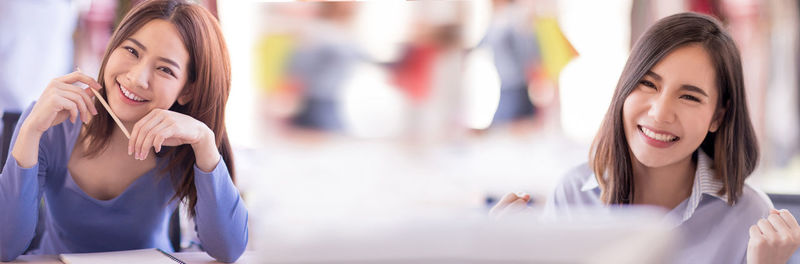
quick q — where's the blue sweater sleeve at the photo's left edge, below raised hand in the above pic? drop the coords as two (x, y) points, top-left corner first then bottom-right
(0, 105), (47, 261)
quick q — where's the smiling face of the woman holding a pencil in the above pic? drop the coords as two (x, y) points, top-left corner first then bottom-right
(103, 19), (189, 123)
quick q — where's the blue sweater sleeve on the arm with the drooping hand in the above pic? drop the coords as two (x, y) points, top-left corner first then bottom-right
(194, 159), (248, 262)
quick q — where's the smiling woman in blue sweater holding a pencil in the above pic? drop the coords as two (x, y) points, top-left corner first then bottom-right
(0, 0), (248, 262)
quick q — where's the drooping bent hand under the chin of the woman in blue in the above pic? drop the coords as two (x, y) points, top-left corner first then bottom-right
(128, 109), (219, 171)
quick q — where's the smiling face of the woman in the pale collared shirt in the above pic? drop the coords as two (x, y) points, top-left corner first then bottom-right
(622, 44), (722, 168)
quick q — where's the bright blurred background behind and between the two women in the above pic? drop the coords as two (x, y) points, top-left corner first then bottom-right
(0, 0), (800, 252)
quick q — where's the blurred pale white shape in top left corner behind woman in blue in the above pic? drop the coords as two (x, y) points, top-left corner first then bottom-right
(0, 0), (78, 166)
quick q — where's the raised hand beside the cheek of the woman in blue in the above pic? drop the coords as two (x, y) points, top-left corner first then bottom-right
(23, 71), (102, 135)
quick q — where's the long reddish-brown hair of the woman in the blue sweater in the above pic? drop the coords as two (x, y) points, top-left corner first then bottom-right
(81, 0), (235, 216)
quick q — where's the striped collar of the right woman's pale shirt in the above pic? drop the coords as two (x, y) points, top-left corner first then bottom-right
(581, 149), (728, 222)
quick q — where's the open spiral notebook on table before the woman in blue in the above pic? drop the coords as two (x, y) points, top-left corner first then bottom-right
(59, 248), (186, 264)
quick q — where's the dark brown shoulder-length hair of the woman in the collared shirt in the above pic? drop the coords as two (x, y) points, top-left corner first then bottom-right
(589, 13), (759, 205)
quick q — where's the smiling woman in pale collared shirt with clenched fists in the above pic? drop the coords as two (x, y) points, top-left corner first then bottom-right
(491, 13), (800, 264)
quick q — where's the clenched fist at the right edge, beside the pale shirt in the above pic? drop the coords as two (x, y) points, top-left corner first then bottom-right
(747, 209), (800, 264)
